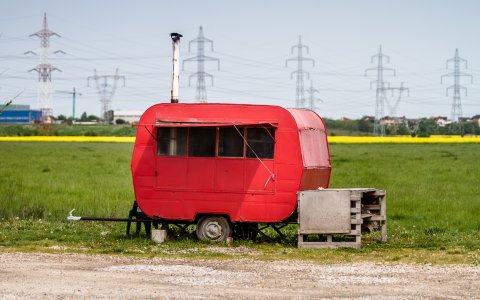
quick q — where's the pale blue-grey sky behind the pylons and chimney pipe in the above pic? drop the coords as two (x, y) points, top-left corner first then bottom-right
(0, 0), (480, 119)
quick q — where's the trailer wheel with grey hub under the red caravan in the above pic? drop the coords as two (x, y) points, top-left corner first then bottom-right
(196, 216), (232, 242)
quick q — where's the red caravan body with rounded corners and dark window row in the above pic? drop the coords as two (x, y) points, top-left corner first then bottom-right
(131, 103), (331, 223)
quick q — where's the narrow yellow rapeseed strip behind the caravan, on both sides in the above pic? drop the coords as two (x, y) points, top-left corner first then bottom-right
(0, 135), (480, 144)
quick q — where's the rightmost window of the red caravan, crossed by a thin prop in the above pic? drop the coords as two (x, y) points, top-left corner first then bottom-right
(247, 128), (275, 158)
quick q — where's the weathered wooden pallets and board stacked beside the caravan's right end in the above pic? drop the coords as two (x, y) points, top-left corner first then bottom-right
(298, 189), (387, 249)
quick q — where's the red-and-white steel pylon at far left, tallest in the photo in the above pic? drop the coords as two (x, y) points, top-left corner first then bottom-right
(25, 13), (65, 122)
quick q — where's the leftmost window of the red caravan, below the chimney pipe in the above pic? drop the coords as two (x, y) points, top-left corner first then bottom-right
(157, 127), (188, 156)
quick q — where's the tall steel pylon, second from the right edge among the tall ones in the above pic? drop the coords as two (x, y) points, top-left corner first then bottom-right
(365, 45), (395, 136)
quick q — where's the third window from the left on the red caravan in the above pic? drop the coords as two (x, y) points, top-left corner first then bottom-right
(218, 127), (244, 157)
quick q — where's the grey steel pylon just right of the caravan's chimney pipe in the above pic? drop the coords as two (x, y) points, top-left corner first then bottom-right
(182, 26), (220, 102)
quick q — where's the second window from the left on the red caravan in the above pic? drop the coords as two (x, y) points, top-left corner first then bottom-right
(188, 127), (217, 157)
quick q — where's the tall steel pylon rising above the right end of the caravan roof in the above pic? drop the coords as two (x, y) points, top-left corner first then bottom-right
(285, 36), (315, 108)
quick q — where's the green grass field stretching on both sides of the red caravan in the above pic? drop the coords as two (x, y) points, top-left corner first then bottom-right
(0, 142), (480, 264)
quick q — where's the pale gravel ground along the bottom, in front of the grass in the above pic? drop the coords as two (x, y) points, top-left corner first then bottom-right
(0, 253), (480, 299)
